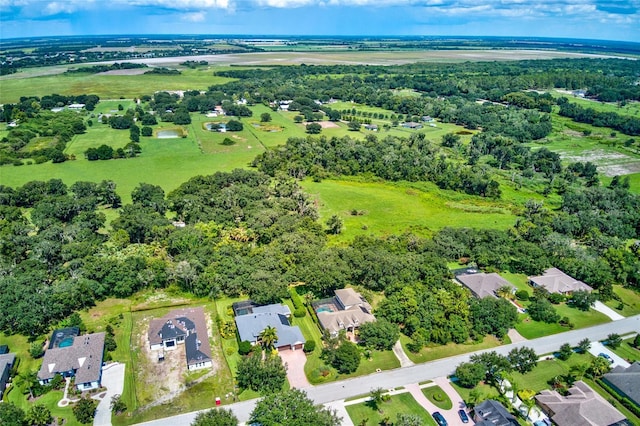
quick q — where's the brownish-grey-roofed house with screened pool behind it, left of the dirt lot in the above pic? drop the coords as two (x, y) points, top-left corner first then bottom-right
(38, 327), (105, 391)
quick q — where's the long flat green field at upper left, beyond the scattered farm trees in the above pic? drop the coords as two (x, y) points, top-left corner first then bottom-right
(0, 68), (233, 104)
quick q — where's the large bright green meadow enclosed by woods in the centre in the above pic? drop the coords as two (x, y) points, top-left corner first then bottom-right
(302, 179), (515, 240)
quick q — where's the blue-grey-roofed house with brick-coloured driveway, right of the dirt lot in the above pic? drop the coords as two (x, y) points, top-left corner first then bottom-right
(235, 303), (306, 351)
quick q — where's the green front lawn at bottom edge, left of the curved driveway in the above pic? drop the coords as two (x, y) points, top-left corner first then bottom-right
(345, 392), (436, 426)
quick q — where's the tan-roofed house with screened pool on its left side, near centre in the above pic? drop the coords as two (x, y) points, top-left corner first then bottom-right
(313, 288), (376, 337)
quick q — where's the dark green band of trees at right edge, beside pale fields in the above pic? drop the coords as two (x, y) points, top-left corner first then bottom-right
(558, 98), (640, 136)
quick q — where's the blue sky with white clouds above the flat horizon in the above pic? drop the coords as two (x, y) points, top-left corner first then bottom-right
(0, 0), (640, 42)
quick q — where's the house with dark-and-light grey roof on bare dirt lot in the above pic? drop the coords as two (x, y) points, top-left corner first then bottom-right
(149, 308), (213, 371)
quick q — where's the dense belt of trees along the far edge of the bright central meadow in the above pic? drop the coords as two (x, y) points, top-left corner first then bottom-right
(253, 134), (501, 198)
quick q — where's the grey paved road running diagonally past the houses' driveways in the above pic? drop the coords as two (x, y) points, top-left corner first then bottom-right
(136, 315), (640, 426)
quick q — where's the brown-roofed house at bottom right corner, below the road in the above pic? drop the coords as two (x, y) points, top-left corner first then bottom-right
(536, 380), (627, 426)
